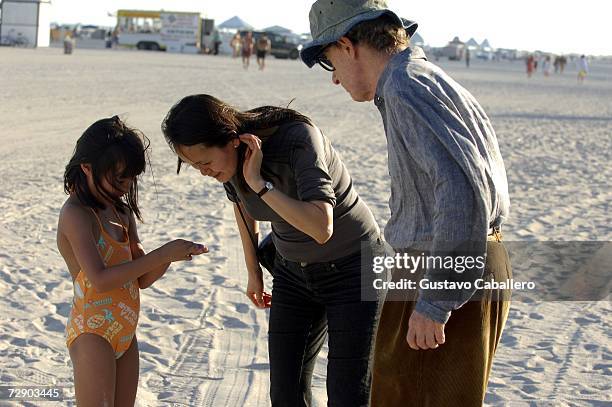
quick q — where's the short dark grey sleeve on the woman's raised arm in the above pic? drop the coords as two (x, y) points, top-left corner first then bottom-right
(290, 126), (336, 206)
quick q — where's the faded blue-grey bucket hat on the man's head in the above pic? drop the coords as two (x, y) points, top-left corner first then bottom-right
(300, 0), (418, 68)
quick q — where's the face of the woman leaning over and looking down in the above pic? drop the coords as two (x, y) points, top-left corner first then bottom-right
(176, 139), (240, 183)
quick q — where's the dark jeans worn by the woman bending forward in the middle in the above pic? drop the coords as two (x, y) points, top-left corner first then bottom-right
(268, 239), (385, 407)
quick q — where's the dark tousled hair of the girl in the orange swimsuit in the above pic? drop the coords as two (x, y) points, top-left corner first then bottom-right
(64, 116), (149, 221)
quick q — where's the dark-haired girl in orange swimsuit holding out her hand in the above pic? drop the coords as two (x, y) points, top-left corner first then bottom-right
(57, 116), (208, 406)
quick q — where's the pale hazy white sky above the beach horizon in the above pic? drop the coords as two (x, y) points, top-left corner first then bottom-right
(40, 0), (612, 55)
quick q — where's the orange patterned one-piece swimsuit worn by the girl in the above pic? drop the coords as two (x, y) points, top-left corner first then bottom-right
(66, 208), (140, 359)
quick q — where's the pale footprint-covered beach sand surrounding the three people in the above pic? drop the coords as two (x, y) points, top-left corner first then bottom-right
(0, 48), (612, 407)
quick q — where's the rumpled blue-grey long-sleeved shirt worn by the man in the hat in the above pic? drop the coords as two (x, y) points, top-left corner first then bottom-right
(374, 47), (510, 323)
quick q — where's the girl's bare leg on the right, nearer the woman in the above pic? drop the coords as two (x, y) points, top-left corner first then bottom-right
(115, 335), (139, 407)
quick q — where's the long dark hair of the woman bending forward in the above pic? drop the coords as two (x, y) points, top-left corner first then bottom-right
(161, 95), (312, 187)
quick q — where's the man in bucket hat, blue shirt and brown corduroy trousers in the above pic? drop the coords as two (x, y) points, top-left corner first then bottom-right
(301, 0), (511, 407)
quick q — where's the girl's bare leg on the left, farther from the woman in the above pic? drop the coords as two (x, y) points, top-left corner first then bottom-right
(69, 333), (116, 407)
